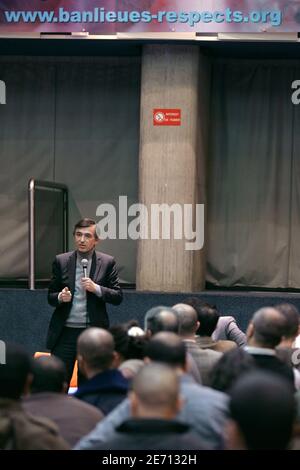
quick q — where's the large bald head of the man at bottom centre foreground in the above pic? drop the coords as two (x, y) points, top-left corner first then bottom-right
(129, 363), (181, 419)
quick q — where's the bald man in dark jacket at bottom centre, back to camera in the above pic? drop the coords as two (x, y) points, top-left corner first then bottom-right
(90, 363), (203, 450)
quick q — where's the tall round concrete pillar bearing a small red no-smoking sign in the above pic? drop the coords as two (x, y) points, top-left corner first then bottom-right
(136, 45), (209, 292)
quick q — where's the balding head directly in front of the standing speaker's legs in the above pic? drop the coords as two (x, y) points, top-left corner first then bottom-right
(77, 328), (115, 370)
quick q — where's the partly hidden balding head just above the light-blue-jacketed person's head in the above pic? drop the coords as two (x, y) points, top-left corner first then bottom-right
(144, 306), (179, 336)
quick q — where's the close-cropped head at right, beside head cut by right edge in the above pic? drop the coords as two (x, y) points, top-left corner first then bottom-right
(248, 307), (285, 348)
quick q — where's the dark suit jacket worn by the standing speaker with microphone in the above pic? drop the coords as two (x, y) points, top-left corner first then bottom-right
(47, 251), (123, 350)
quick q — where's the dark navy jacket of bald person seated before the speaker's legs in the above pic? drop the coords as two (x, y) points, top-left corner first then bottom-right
(74, 369), (128, 415)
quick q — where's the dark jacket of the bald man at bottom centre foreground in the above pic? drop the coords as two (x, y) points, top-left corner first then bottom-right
(94, 418), (204, 450)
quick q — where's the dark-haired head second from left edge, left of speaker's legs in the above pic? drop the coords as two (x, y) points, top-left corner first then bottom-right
(31, 356), (68, 393)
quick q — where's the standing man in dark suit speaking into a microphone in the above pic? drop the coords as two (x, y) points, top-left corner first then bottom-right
(47, 219), (122, 382)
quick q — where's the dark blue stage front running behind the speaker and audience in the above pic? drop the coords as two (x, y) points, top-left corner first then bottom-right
(0, 289), (300, 353)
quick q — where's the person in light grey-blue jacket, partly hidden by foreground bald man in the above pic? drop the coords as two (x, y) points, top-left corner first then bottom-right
(75, 332), (228, 449)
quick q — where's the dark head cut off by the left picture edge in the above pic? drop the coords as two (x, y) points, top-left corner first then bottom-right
(0, 343), (32, 400)
